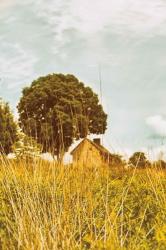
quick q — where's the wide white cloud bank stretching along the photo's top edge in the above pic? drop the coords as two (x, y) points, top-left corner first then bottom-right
(31, 0), (166, 36)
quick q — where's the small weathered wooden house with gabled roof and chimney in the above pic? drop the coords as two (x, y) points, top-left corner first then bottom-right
(71, 138), (111, 167)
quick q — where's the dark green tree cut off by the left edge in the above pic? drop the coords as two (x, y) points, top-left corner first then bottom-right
(0, 99), (18, 154)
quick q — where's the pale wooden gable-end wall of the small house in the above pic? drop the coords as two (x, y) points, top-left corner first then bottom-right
(73, 140), (103, 167)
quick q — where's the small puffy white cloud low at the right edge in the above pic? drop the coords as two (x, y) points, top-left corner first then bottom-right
(146, 115), (166, 137)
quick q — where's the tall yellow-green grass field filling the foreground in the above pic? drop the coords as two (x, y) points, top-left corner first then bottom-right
(0, 159), (166, 250)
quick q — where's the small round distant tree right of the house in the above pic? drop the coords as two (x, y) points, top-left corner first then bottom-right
(129, 152), (150, 168)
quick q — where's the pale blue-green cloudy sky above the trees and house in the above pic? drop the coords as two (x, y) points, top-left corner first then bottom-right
(0, 0), (166, 158)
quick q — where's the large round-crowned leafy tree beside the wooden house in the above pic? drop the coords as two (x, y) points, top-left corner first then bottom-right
(18, 74), (107, 159)
